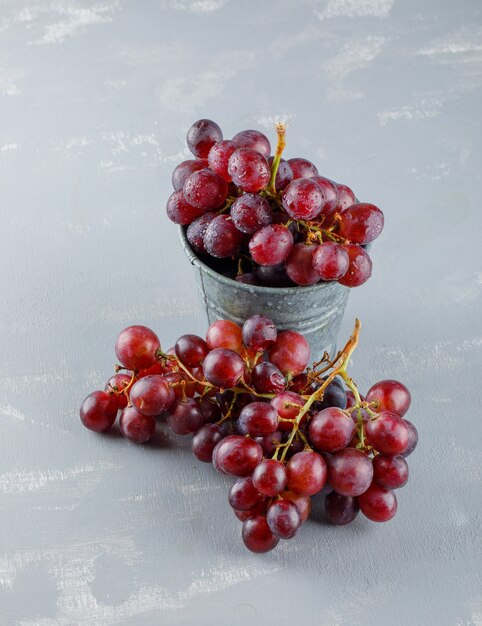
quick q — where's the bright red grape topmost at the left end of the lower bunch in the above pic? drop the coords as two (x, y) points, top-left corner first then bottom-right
(115, 326), (161, 370)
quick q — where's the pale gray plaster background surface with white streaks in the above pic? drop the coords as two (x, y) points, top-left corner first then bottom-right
(0, 0), (482, 626)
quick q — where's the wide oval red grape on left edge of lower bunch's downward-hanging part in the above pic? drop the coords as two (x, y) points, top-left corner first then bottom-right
(213, 435), (263, 476)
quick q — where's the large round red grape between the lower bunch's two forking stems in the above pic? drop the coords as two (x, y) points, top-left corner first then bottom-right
(309, 407), (355, 452)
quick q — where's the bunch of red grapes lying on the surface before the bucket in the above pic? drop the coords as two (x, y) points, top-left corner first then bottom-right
(80, 315), (418, 552)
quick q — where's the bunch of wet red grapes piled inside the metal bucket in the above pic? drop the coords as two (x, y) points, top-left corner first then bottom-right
(167, 119), (384, 287)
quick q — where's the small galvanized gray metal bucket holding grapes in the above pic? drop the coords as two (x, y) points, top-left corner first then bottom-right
(179, 227), (350, 360)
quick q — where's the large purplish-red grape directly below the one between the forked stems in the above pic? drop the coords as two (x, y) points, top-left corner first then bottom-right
(328, 448), (373, 496)
